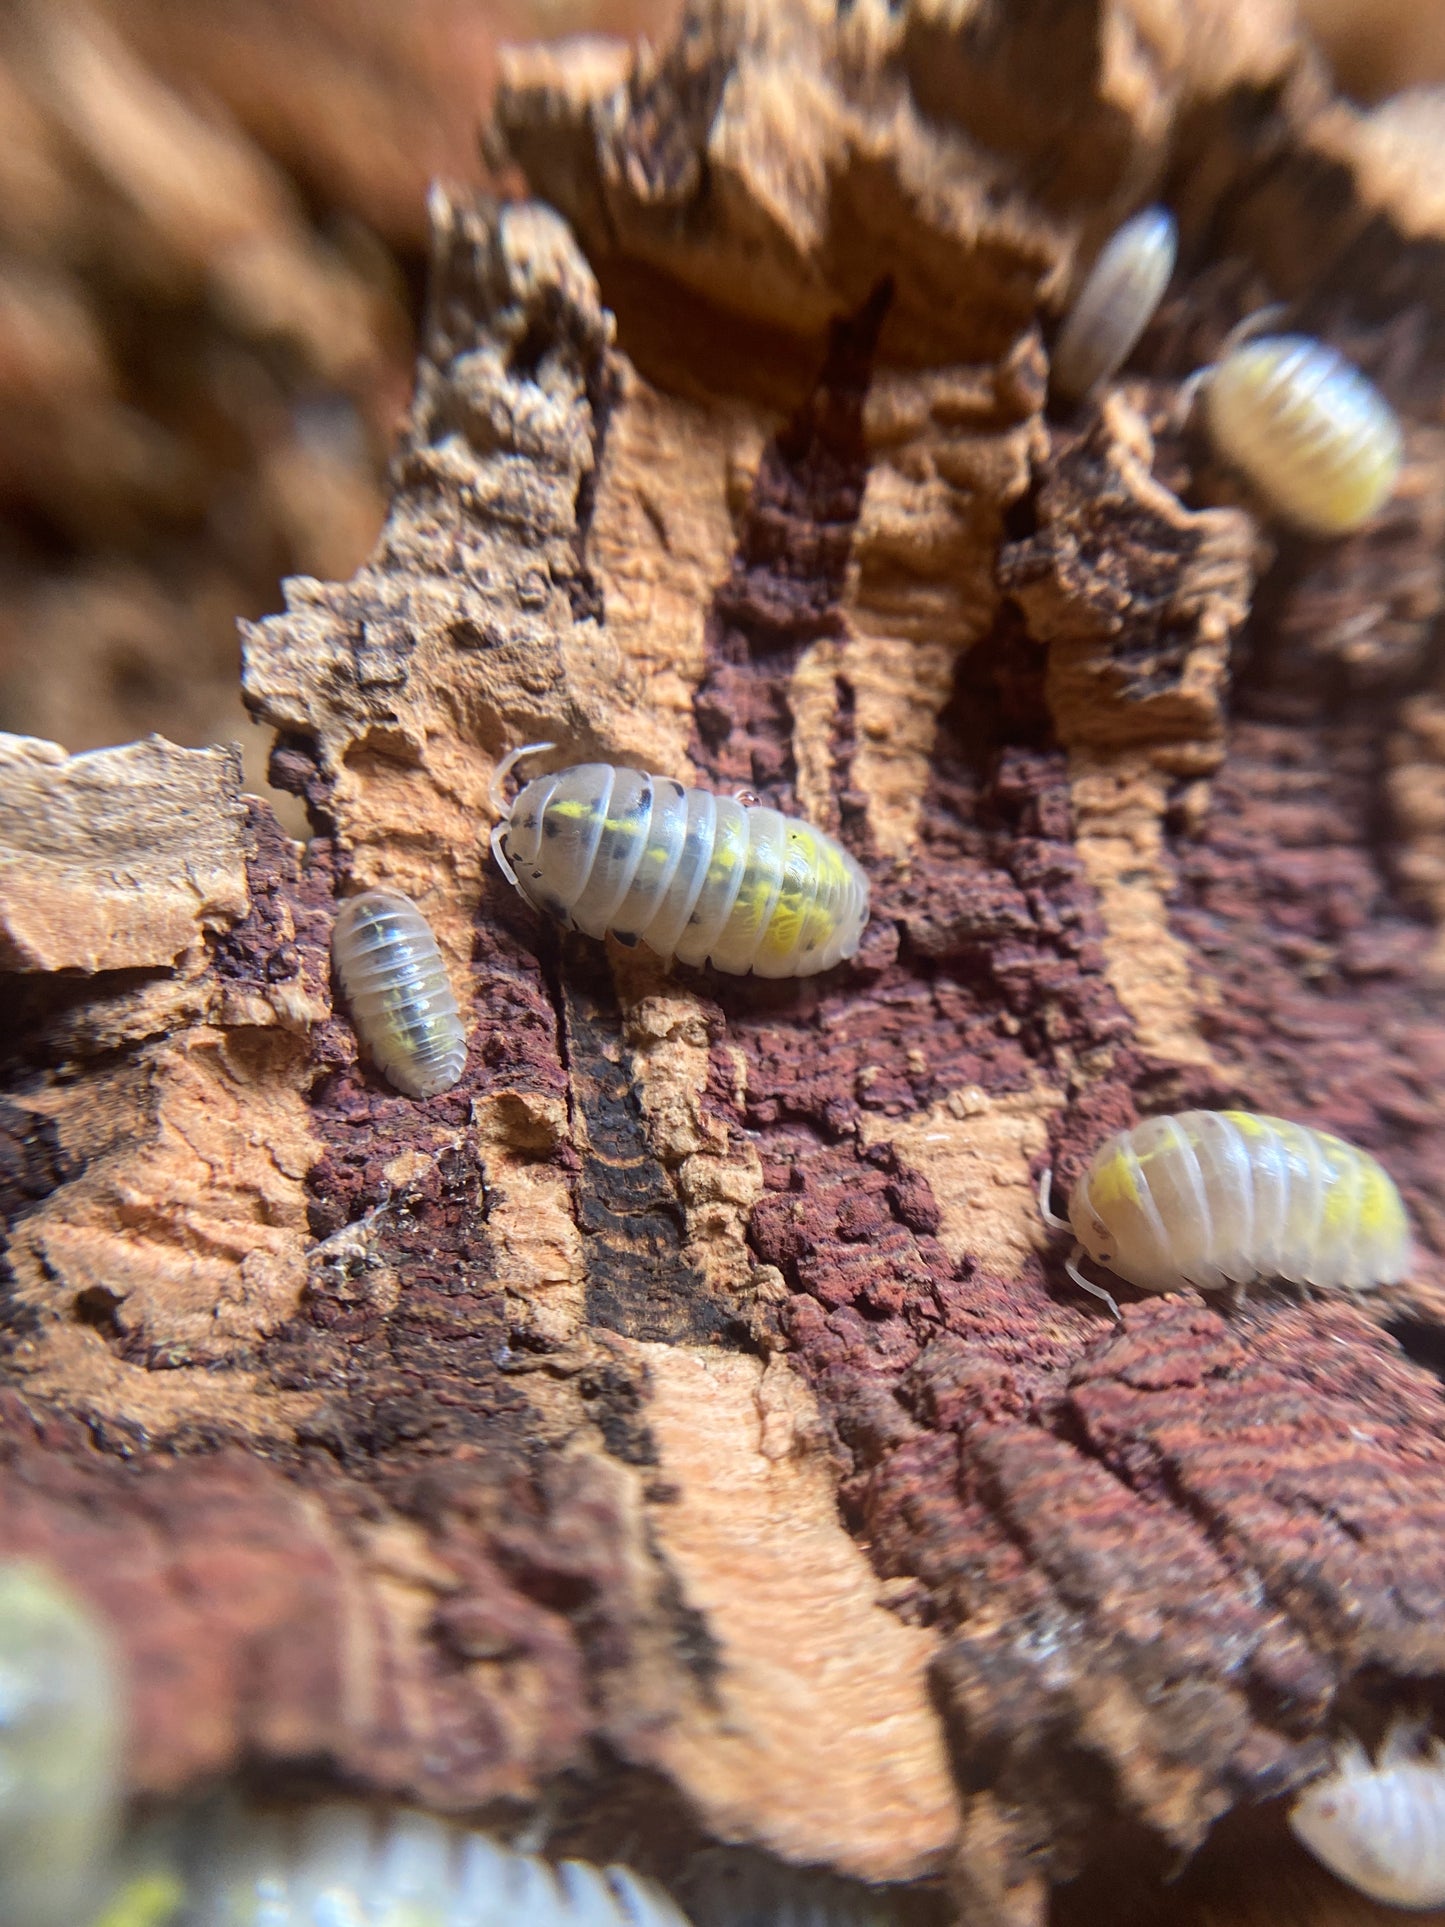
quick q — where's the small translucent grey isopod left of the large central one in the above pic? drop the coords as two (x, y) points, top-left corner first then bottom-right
(331, 890), (466, 1096)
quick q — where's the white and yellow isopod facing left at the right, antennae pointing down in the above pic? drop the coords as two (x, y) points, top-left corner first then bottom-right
(1040, 1110), (1410, 1318)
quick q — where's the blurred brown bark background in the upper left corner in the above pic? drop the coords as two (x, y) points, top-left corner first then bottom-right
(0, 0), (667, 829)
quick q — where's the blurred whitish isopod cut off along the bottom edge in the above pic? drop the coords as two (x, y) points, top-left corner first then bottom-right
(168, 1800), (688, 1927)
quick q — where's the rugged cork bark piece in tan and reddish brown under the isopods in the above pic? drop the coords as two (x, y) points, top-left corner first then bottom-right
(0, 0), (1445, 1927)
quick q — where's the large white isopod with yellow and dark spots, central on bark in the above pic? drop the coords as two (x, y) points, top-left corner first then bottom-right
(491, 742), (869, 977)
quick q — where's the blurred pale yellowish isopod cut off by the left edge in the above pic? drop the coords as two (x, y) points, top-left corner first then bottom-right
(0, 1561), (121, 1927)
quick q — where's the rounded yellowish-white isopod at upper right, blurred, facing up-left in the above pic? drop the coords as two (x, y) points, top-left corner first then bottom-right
(1202, 335), (1403, 536)
